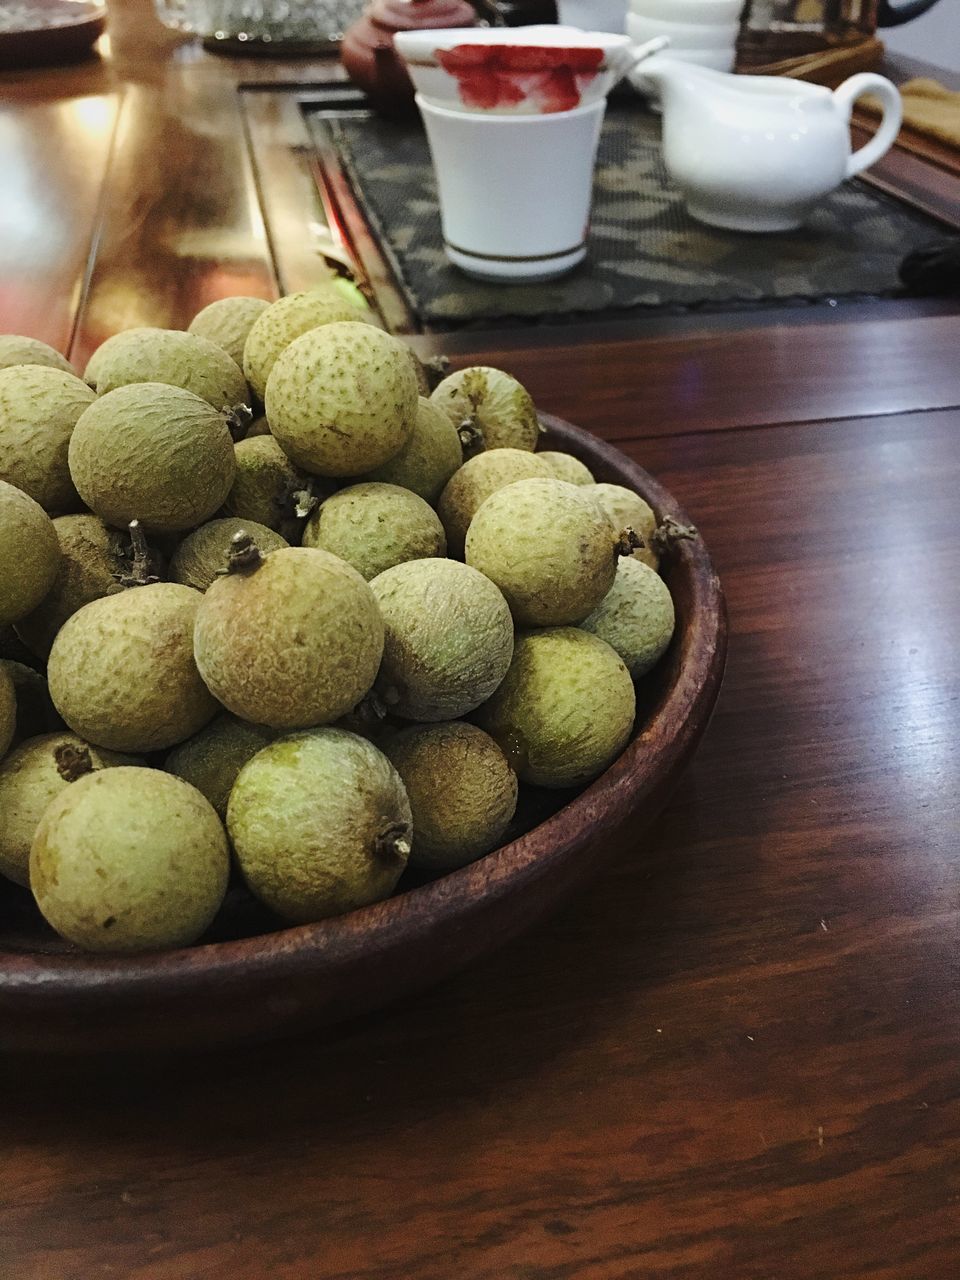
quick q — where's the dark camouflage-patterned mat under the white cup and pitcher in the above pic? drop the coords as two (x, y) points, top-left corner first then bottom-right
(311, 104), (942, 329)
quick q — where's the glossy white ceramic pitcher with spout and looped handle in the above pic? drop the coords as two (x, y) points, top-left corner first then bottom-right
(641, 54), (902, 232)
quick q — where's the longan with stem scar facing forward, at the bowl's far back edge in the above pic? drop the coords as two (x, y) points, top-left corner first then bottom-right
(430, 365), (541, 451)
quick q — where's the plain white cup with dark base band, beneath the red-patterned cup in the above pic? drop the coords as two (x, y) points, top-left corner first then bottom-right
(416, 93), (607, 284)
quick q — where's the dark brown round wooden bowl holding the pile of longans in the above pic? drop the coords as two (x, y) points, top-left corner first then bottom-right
(0, 416), (727, 1052)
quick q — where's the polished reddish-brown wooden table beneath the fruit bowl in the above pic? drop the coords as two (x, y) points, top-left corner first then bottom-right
(0, 0), (960, 1280)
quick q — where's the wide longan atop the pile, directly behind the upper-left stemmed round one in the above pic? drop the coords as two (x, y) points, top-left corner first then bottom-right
(97, 329), (250, 410)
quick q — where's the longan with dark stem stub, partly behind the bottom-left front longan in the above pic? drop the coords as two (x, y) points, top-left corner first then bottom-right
(0, 732), (142, 884)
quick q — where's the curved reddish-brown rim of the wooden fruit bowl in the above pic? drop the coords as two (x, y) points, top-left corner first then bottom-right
(0, 413), (726, 1016)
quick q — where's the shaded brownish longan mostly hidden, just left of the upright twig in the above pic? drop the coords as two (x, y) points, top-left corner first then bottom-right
(17, 516), (130, 658)
